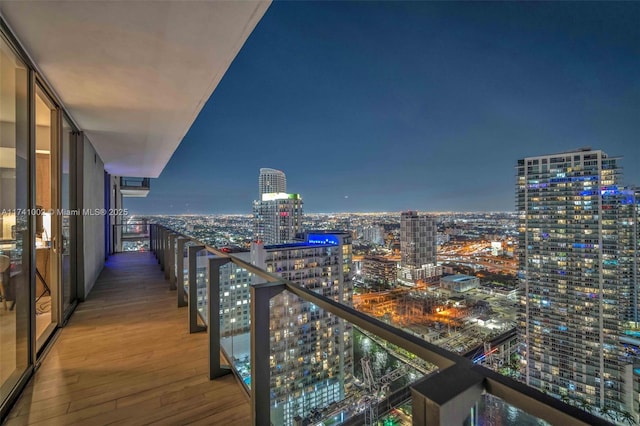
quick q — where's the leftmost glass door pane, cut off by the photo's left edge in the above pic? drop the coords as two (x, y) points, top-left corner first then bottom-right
(0, 30), (32, 410)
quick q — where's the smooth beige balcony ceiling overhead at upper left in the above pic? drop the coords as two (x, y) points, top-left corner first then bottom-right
(0, 0), (270, 177)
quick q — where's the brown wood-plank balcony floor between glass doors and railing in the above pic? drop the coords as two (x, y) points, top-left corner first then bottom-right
(6, 253), (251, 425)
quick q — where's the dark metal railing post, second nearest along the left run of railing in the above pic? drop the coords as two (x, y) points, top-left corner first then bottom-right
(207, 257), (233, 380)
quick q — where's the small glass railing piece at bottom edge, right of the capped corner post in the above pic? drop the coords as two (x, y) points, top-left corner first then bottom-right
(464, 393), (550, 426)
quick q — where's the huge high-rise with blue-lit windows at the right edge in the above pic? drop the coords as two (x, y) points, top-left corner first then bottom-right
(516, 148), (638, 418)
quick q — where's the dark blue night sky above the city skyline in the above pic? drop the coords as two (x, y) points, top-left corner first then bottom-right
(125, 2), (640, 214)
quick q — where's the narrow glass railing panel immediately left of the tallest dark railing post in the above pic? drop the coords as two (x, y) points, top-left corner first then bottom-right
(219, 253), (254, 389)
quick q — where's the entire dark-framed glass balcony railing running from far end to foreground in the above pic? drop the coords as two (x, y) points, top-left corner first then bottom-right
(150, 225), (608, 426)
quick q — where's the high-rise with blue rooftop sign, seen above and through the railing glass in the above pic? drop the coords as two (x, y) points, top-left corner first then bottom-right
(251, 231), (353, 425)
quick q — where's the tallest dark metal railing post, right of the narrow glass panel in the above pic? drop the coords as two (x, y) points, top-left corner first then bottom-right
(251, 283), (285, 426)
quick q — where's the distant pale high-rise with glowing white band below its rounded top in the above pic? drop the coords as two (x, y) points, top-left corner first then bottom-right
(253, 168), (303, 244)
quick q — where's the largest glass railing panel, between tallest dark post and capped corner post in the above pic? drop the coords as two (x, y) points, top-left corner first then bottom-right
(269, 291), (437, 425)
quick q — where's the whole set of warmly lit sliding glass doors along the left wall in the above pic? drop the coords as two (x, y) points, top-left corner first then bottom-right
(0, 21), (79, 416)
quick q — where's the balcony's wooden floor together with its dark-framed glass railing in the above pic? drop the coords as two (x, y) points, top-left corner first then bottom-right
(7, 225), (608, 425)
